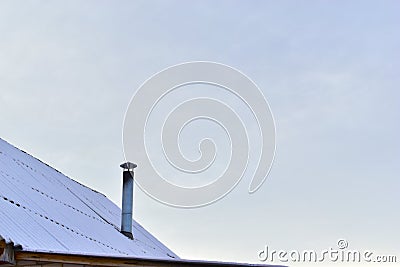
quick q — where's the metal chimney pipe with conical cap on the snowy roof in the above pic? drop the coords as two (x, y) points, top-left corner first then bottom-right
(120, 162), (137, 239)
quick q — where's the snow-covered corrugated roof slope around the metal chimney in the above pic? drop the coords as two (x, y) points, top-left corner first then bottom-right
(0, 139), (178, 259)
